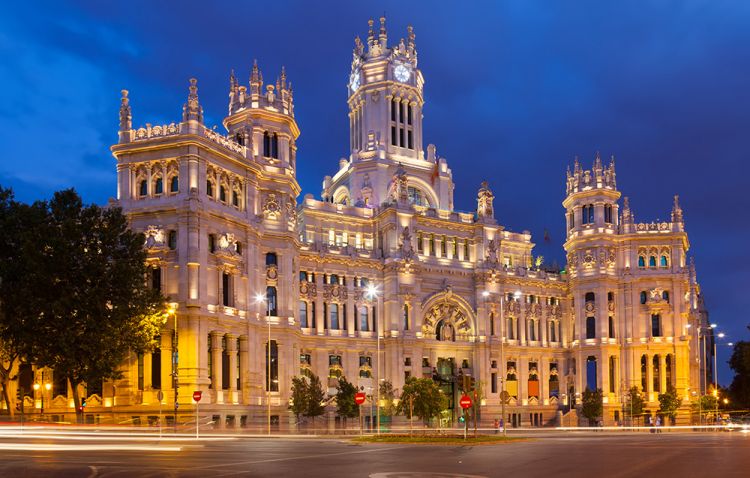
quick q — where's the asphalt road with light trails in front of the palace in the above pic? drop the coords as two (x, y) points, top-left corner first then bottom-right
(0, 432), (750, 478)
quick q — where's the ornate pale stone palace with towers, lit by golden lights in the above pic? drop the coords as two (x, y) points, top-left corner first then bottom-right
(11, 19), (705, 426)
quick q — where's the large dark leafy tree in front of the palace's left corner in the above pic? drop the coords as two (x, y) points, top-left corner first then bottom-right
(22, 189), (167, 413)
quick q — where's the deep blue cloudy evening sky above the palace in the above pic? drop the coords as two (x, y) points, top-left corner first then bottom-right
(0, 0), (750, 381)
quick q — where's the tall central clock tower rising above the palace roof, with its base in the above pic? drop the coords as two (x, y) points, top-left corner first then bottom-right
(323, 17), (453, 210)
